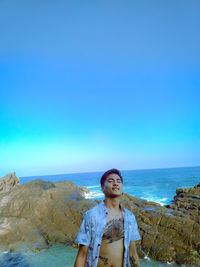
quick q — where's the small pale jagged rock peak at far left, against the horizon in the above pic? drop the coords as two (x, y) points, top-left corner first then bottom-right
(0, 172), (19, 193)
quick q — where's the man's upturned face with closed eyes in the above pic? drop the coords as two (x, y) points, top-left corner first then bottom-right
(102, 173), (123, 197)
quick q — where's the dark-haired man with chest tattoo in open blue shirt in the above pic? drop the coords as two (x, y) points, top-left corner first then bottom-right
(74, 169), (140, 267)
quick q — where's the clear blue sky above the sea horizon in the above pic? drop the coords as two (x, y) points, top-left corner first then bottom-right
(0, 0), (200, 176)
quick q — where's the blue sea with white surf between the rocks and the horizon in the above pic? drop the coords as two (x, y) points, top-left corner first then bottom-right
(20, 167), (200, 205)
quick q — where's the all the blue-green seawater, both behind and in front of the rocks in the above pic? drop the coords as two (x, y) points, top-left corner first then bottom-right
(0, 167), (200, 267)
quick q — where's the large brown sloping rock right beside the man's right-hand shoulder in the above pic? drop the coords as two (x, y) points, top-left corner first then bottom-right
(122, 194), (200, 266)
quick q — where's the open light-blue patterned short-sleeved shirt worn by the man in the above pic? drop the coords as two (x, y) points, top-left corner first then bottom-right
(76, 202), (140, 267)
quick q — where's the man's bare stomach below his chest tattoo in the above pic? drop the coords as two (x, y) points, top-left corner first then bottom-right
(97, 238), (124, 267)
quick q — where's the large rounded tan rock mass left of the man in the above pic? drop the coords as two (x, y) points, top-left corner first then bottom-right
(0, 179), (95, 254)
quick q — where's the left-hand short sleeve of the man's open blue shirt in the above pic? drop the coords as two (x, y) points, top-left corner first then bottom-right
(75, 213), (90, 246)
